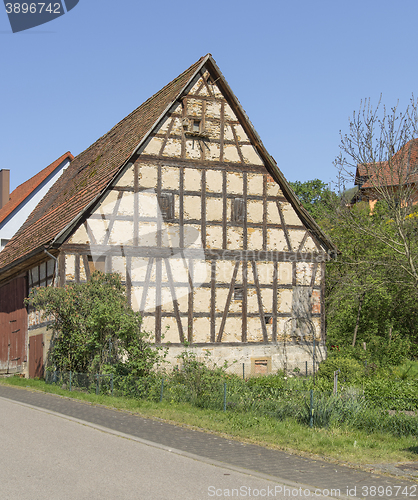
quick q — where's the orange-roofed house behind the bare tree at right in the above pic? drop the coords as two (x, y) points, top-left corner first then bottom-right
(352, 139), (418, 209)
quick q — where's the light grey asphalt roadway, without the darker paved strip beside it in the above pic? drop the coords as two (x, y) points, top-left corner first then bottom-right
(0, 398), (334, 500)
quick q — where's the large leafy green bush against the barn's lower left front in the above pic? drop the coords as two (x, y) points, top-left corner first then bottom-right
(27, 271), (164, 378)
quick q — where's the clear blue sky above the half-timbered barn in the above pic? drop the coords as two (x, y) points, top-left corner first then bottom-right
(0, 0), (418, 190)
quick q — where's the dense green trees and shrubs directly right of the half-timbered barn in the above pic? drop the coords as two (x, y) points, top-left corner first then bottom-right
(293, 179), (418, 364)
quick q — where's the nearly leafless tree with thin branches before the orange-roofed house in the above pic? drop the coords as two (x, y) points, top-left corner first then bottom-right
(335, 99), (418, 292)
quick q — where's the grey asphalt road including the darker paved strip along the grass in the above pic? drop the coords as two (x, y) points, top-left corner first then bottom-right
(0, 384), (418, 500)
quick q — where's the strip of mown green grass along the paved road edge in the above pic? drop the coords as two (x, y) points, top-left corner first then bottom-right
(0, 377), (418, 465)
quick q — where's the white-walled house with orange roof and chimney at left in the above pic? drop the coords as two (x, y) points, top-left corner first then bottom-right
(0, 152), (74, 250)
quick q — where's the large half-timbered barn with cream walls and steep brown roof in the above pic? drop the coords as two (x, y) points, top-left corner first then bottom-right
(0, 54), (336, 375)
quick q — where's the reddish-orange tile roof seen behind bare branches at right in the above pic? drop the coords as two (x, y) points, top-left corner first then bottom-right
(355, 139), (418, 189)
